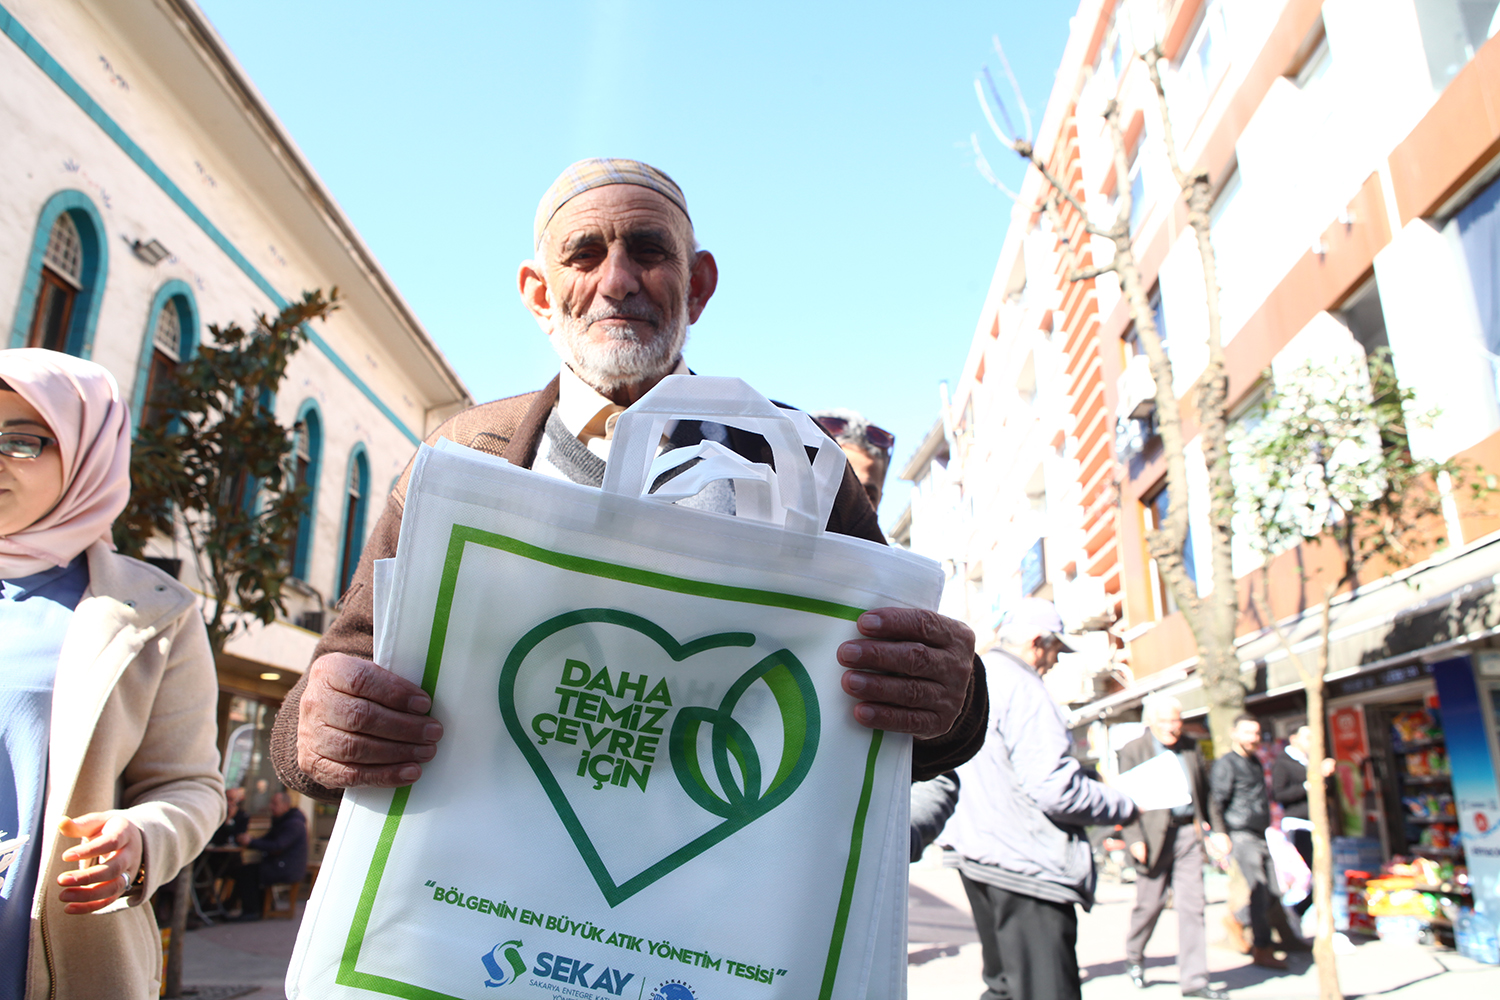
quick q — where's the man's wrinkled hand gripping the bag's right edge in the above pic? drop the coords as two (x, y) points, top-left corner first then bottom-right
(839, 607), (974, 739)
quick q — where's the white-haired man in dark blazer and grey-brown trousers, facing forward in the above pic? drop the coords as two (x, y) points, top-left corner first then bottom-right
(1119, 696), (1229, 1000)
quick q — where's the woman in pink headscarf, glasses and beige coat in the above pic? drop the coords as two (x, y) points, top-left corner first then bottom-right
(0, 349), (224, 999)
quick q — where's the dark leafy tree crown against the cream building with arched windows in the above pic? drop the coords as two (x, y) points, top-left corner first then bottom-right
(114, 288), (339, 655)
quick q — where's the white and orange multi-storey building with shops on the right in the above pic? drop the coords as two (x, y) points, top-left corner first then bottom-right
(908, 0), (1500, 893)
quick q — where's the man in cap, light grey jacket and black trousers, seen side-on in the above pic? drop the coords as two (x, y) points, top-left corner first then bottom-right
(941, 598), (1136, 1000)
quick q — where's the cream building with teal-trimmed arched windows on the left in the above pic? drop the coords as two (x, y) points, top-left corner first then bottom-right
(0, 0), (471, 803)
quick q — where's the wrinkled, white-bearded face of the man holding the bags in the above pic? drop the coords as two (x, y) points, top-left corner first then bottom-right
(519, 184), (717, 394)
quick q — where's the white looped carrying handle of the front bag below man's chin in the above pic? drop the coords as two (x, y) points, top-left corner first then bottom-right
(603, 375), (846, 535)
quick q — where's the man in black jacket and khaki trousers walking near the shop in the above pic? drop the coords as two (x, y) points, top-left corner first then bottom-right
(1209, 715), (1307, 969)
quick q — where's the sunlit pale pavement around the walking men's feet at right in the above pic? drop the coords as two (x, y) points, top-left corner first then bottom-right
(908, 859), (1500, 1000)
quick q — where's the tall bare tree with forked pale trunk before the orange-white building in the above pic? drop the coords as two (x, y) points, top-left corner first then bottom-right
(971, 37), (1245, 754)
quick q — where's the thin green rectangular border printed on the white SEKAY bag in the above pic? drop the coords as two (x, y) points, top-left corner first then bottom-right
(335, 525), (885, 1000)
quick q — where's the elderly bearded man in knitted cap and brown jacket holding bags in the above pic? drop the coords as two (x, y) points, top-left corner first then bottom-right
(272, 159), (987, 799)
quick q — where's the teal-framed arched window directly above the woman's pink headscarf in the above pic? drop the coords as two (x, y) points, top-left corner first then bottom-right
(11, 190), (108, 357)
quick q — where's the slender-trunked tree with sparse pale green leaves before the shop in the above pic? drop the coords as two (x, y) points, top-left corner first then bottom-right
(1230, 349), (1488, 1000)
